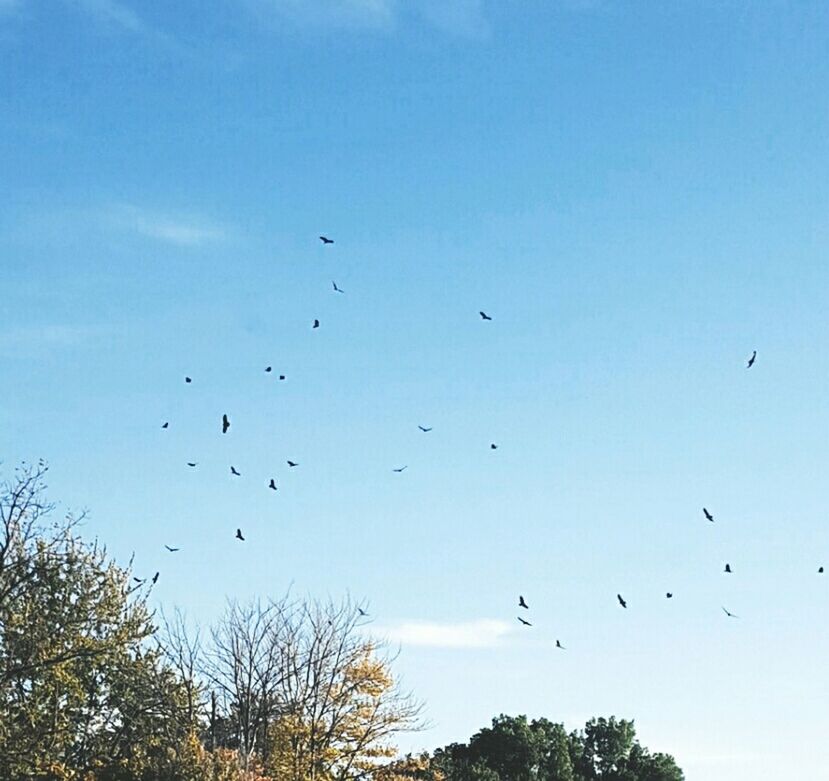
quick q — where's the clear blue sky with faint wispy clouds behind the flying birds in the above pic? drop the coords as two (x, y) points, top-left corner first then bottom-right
(0, 0), (829, 781)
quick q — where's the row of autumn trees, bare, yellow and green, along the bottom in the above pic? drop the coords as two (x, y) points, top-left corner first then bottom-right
(0, 463), (682, 781)
